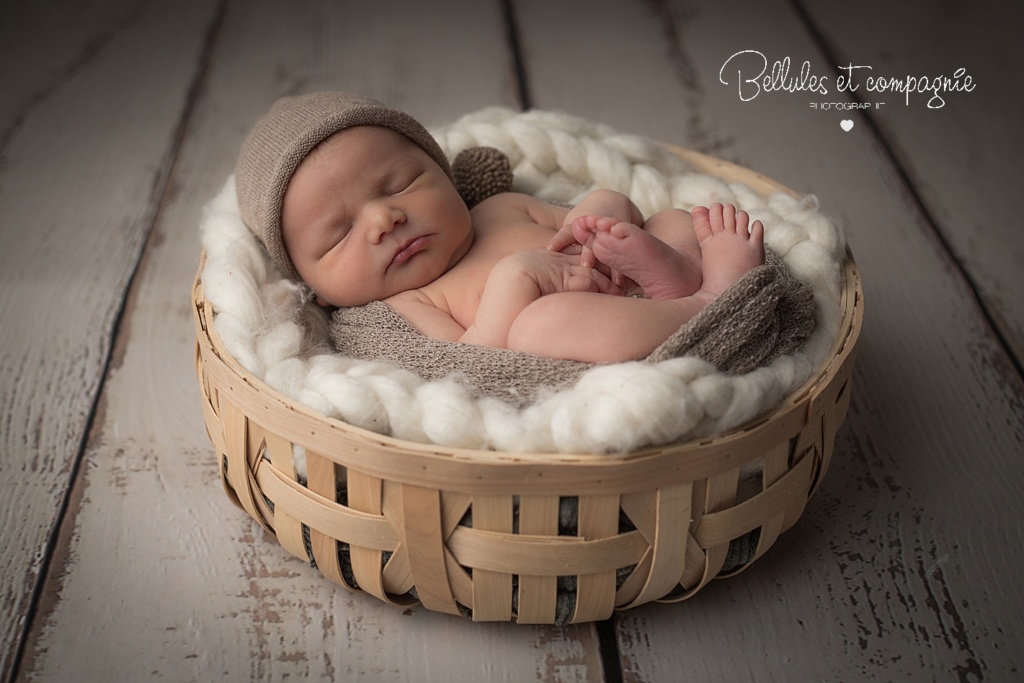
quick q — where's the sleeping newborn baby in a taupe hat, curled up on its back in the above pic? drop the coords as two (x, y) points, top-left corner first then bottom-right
(237, 92), (765, 362)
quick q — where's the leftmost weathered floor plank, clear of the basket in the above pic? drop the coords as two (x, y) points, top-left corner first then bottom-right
(0, 2), (220, 678)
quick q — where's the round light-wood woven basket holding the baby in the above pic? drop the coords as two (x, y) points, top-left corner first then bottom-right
(193, 147), (863, 624)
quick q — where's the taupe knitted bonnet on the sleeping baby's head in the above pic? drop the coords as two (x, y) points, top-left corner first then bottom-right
(234, 92), (454, 281)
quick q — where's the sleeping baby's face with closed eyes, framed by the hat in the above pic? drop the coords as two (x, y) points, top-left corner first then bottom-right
(282, 126), (473, 306)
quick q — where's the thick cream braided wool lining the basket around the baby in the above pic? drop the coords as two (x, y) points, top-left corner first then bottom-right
(201, 108), (846, 475)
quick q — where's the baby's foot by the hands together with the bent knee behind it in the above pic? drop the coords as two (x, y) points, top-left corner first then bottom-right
(572, 209), (701, 299)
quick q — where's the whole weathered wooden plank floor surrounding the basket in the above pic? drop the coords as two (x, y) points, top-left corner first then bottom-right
(0, 0), (1024, 682)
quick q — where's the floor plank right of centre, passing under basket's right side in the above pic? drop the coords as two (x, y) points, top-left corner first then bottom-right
(516, 0), (1024, 681)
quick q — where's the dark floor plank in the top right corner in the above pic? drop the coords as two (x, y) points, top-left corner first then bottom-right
(807, 0), (1024, 367)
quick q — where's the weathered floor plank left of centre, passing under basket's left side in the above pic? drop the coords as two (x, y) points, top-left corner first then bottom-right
(16, 0), (601, 682)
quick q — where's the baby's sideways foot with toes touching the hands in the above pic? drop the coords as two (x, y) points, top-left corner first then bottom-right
(572, 216), (701, 299)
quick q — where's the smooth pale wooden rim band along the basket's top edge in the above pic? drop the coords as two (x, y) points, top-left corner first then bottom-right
(191, 144), (863, 493)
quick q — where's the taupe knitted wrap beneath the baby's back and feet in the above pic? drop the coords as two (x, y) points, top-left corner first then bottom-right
(331, 250), (814, 407)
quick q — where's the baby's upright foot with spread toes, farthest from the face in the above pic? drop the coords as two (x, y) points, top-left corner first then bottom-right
(691, 202), (765, 297)
